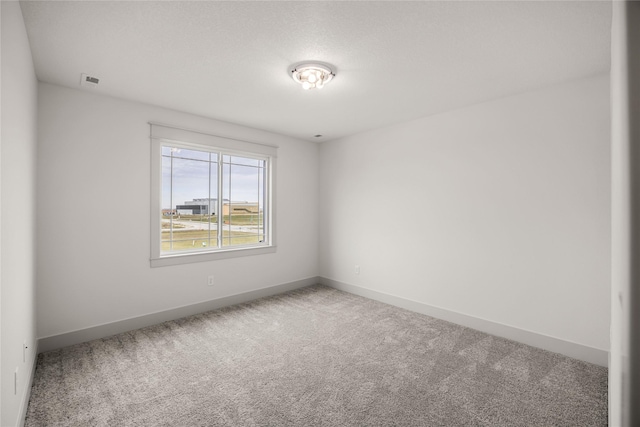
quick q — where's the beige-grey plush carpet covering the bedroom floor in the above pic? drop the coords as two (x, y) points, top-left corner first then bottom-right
(26, 286), (607, 427)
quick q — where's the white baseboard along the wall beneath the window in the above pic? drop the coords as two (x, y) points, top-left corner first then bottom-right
(38, 277), (320, 352)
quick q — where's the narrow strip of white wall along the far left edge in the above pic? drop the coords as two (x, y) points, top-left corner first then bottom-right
(0, 1), (37, 426)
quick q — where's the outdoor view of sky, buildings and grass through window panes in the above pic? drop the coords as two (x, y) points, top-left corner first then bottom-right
(158, 143), (269, 255)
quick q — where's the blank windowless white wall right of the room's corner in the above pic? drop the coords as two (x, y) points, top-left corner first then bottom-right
(320, 76), (611, 356)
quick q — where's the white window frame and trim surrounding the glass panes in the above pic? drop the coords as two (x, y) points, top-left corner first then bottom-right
(149, 122), (278, 267)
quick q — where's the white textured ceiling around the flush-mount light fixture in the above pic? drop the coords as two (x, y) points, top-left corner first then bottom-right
(21, 1), (611, 141)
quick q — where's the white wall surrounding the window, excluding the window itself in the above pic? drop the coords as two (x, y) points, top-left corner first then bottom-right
(37, 83), (319, 337)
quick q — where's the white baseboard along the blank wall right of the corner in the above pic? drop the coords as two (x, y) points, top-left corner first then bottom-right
(320, 277), (609, 367)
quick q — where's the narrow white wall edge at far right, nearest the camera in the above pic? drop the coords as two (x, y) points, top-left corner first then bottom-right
(609, 1), (640, 426)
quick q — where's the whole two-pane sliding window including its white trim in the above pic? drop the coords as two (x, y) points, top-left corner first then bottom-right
(151, 124), (276, 266)
